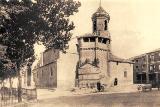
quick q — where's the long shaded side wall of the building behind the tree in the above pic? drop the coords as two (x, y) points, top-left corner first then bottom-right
(32, 48), (59, 88)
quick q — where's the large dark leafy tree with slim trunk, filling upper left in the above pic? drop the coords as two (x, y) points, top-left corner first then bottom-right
(0, 0), (80, 102)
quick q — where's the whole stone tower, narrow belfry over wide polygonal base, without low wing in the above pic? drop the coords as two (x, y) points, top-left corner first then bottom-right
(76, 5), (111, 88)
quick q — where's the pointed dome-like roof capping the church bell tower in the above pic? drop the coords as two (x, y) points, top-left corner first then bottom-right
(92, 6), (110, 20)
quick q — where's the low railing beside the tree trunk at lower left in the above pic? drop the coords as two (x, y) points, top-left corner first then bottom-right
(0, 87), (37, 107)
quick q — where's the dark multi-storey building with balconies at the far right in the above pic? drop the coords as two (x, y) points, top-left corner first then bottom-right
(131, 49), (160, 86)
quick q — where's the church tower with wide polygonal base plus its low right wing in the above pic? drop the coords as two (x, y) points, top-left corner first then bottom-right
(75, 5), (133, 88)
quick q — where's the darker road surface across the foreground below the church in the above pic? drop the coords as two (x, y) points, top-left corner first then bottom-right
(29, 90), (160, 107)
